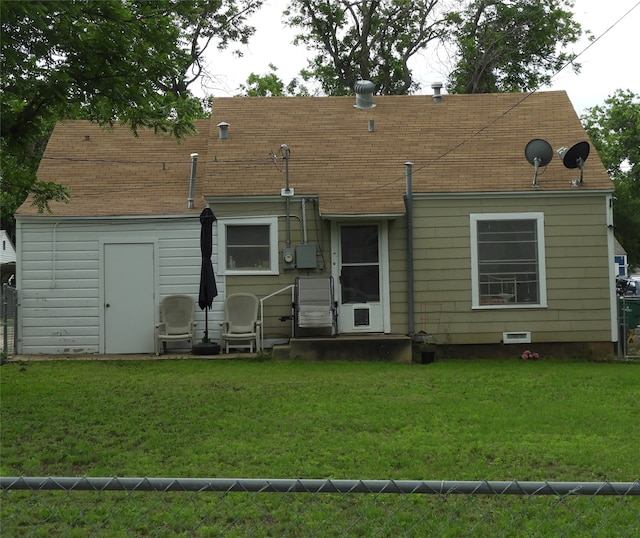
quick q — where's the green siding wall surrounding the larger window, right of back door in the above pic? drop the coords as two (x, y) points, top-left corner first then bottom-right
(408, 193), (611, 344)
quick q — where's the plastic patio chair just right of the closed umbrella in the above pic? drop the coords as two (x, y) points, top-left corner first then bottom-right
(220, 293), (262, 353)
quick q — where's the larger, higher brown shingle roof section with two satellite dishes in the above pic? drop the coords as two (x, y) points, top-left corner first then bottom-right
(207, 92), (611, 214)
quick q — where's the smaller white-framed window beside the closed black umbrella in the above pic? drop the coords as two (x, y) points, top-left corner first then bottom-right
(218, 217), (278, 274)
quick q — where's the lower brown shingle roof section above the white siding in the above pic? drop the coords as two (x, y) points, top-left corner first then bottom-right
(17, 120), (210, 216)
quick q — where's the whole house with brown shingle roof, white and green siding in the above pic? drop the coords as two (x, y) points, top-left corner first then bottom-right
(16, 88), (617, 355)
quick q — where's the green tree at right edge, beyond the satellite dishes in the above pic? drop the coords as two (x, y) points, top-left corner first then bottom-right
(581, 90), (640, 267)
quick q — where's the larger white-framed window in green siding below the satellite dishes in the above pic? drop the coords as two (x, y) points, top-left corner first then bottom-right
(471, 213), (547, 308)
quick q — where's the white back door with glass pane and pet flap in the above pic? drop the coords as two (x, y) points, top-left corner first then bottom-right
(332, 223), (388, 334)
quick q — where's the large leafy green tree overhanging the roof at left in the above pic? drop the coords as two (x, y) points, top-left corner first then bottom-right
(0, 0), (263, 236)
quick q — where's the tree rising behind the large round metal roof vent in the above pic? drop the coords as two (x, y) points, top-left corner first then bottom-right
(285, 0), (448, 95)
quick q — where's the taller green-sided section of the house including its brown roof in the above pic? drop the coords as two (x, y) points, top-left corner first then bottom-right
(206, 92), (617, 355)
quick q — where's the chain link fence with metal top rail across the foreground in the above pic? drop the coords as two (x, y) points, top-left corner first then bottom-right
(0, 477), (640, 538)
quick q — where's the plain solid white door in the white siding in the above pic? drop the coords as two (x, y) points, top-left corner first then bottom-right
(103, 243), (155, 353)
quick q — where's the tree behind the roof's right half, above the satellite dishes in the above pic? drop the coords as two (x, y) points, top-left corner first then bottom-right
(447, 0), (582, 93)
